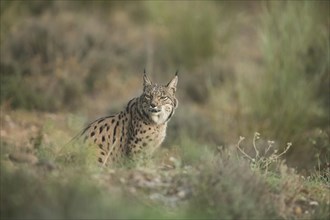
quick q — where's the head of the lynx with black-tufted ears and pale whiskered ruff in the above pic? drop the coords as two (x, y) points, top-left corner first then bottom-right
(140, 73), (178, 125)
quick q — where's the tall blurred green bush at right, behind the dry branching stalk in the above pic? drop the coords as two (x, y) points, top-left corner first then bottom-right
(241, 1), (329, 148)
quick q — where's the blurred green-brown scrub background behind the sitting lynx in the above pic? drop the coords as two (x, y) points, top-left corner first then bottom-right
(0, 0), (330, 218)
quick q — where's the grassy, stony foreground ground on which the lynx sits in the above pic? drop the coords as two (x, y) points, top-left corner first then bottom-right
(0, 111), (330, 219)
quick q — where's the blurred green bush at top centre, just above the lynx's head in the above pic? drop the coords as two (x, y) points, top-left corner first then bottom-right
(146, 2), (218, 67)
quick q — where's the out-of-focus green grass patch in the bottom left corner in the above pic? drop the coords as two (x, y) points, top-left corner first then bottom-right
(1, 161), (173, 219)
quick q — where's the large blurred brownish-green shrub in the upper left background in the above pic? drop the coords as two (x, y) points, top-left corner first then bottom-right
(0, 3), (147, 111)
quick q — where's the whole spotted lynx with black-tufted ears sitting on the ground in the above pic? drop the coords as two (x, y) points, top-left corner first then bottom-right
(82, 74), (178, 165)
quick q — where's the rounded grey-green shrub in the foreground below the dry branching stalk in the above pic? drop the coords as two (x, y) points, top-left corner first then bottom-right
(188, 147), (279, 219)
